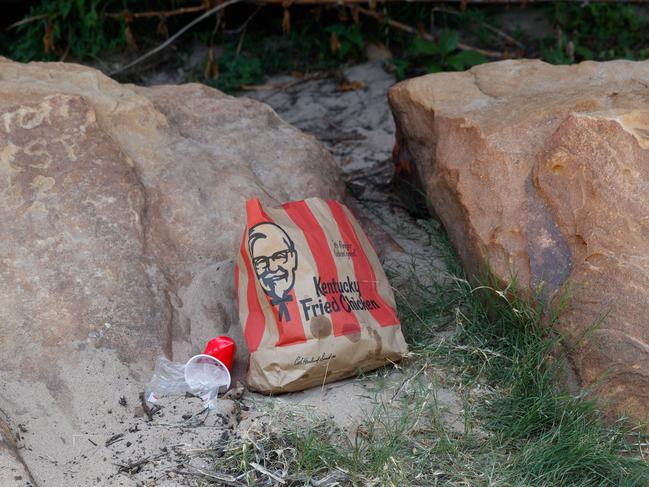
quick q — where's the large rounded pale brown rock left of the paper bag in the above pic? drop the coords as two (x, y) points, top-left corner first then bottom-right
(0, 58), (343, 485)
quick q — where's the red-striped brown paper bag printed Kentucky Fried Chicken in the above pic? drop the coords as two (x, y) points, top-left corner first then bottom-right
(235, 198), (407, 393)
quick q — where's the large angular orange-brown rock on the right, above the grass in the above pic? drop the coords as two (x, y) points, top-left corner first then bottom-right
(390, 61), (649, 420)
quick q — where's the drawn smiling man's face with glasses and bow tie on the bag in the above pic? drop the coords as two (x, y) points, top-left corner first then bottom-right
(248, 222), (297, 321)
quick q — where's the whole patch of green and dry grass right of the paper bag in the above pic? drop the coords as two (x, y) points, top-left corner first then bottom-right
(197, 226), (649, 487)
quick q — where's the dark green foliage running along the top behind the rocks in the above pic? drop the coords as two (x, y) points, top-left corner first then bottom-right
(0, 0), (649, 91)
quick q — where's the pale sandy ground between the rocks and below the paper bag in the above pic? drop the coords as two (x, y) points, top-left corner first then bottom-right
(0, 62), (462, 487)
